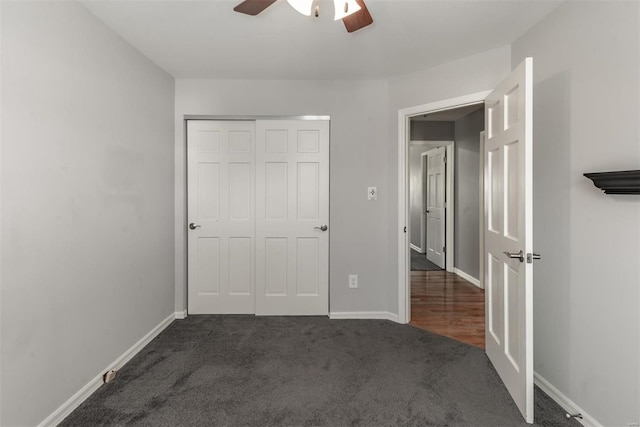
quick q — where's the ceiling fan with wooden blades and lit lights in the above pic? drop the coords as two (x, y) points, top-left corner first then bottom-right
(233, 0), (373, 33)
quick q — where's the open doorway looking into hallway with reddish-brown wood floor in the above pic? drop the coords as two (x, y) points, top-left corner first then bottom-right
(408, 95), (485, 348)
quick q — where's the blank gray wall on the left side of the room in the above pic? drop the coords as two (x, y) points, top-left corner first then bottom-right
(0, 2), (174, 426)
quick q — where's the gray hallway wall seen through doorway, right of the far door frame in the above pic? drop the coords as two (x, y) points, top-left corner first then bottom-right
(454, 109), (484, 279)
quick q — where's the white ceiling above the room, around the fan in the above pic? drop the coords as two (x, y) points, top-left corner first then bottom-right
(82, 0), (561, 79)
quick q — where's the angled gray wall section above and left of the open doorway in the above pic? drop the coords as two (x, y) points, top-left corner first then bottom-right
(385, 46), (511, 313)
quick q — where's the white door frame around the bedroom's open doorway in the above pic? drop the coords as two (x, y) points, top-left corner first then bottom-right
(398, 90), (491, 323)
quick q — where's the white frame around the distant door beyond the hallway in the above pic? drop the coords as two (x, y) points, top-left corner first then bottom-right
(416, 141), (456, 273)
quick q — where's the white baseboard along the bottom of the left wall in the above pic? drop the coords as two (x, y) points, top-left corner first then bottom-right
(38, 313), (176, 427)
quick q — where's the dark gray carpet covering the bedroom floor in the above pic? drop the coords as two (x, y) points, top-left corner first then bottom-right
(61, 316), (579, 427)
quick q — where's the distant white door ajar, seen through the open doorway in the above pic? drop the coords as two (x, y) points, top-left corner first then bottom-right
(425, 147), (446, 269)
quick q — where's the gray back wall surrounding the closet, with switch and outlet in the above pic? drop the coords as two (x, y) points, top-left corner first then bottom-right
(175, 79), (388, 312)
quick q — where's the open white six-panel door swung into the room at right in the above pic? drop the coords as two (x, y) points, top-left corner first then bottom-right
(484, 58), (533, 423)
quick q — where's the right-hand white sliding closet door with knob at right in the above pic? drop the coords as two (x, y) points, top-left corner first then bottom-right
(256, 120), (329, 315)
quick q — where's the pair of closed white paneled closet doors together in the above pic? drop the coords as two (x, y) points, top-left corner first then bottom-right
(187, 120), (329, 315)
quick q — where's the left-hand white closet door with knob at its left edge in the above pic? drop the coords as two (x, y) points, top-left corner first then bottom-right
(186, 120), (256, 314)
